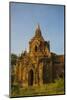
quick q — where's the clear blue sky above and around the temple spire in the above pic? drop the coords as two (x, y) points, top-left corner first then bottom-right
(10, 3), (64, 55)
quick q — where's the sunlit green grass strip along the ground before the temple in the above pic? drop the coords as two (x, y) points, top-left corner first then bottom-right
(11, 79), (64, 97)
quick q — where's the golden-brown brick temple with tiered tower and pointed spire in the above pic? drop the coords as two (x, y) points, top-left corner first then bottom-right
(12, 25), (63, 87)
